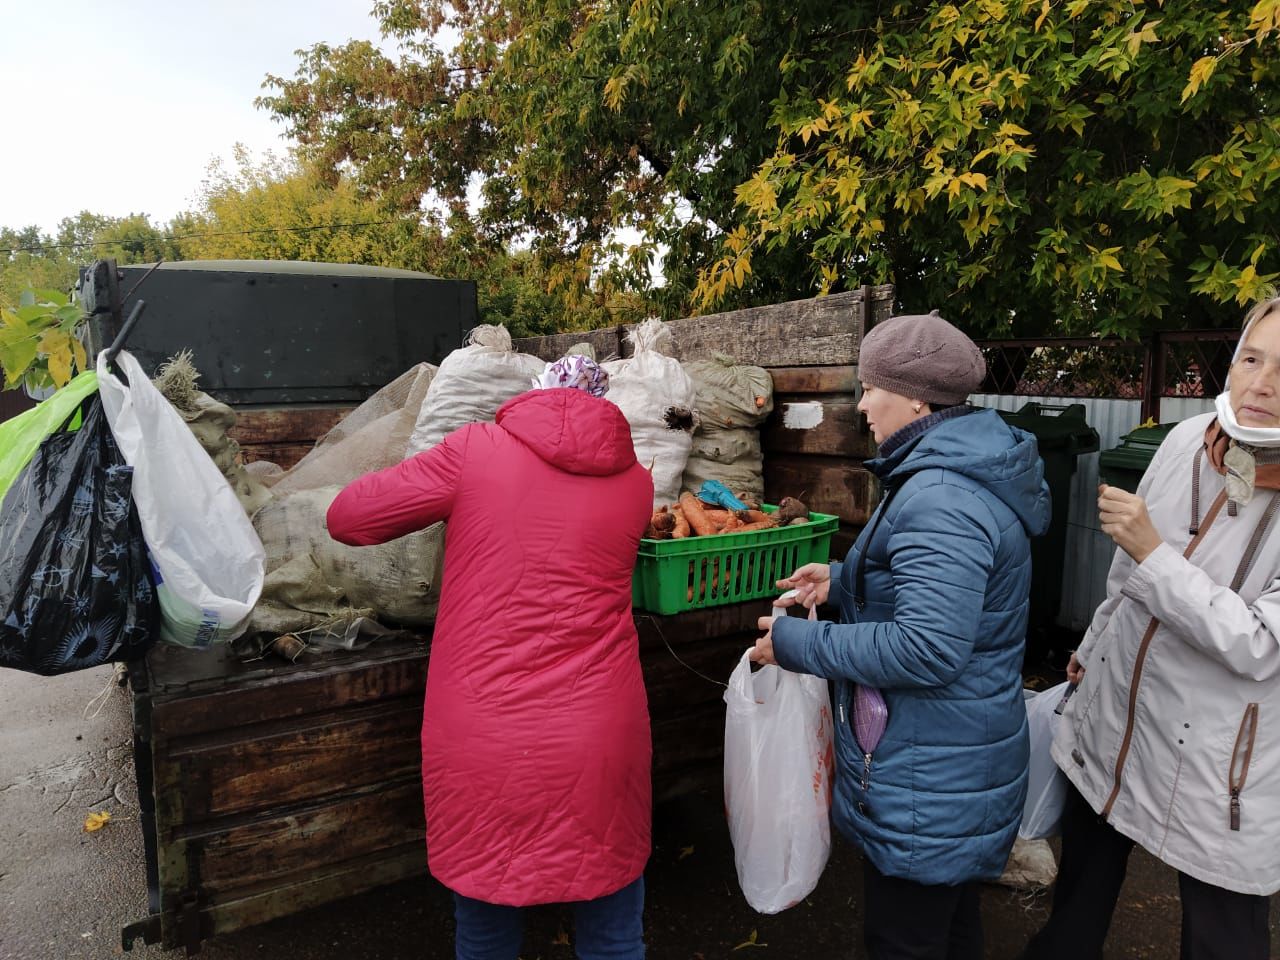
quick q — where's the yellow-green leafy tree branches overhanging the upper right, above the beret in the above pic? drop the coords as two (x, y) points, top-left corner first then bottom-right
(700, 0), (1280, 335)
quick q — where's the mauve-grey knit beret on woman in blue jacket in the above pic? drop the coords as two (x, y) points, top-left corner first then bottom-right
(858, 310), (987, 406)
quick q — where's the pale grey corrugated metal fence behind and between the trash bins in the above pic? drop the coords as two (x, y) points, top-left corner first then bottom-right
(969, 393), (1146, 630)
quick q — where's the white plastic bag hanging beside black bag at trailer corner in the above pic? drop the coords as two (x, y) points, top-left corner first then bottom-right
(97, 351), (264, 648)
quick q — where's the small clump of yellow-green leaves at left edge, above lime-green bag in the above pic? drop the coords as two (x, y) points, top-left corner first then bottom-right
(0, 291), (88, 390)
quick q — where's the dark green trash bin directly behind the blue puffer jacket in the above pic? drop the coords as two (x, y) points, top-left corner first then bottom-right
(1000, 402), (1098, 647)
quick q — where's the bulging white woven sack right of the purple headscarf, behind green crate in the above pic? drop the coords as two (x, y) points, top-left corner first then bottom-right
(600, 320), (694, 506)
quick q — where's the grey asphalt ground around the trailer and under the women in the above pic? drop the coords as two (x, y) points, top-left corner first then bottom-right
(0, 668), (1280, 960)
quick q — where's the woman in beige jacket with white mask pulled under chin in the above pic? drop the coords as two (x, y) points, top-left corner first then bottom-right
(1024, 298), (1280, 960)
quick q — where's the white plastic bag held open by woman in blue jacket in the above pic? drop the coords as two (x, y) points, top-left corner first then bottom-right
(724, 652), (835, 914)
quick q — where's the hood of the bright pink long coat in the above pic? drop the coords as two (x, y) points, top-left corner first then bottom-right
(497, 387), (636, 476)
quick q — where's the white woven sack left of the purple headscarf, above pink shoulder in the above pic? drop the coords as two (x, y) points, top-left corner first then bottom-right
(404, 324), (547, 457)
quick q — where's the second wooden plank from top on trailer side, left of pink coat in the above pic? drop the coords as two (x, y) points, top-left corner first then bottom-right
(155, 698), (422, 824)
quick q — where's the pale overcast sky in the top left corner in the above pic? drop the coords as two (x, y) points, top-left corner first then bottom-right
(0, 0), (392, 232)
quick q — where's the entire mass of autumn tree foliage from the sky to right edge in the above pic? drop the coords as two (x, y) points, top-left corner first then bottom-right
(261, 0), (1280, 334)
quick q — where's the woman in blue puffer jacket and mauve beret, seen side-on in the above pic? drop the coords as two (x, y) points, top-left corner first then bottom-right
(753, 311), (1050, 960)
